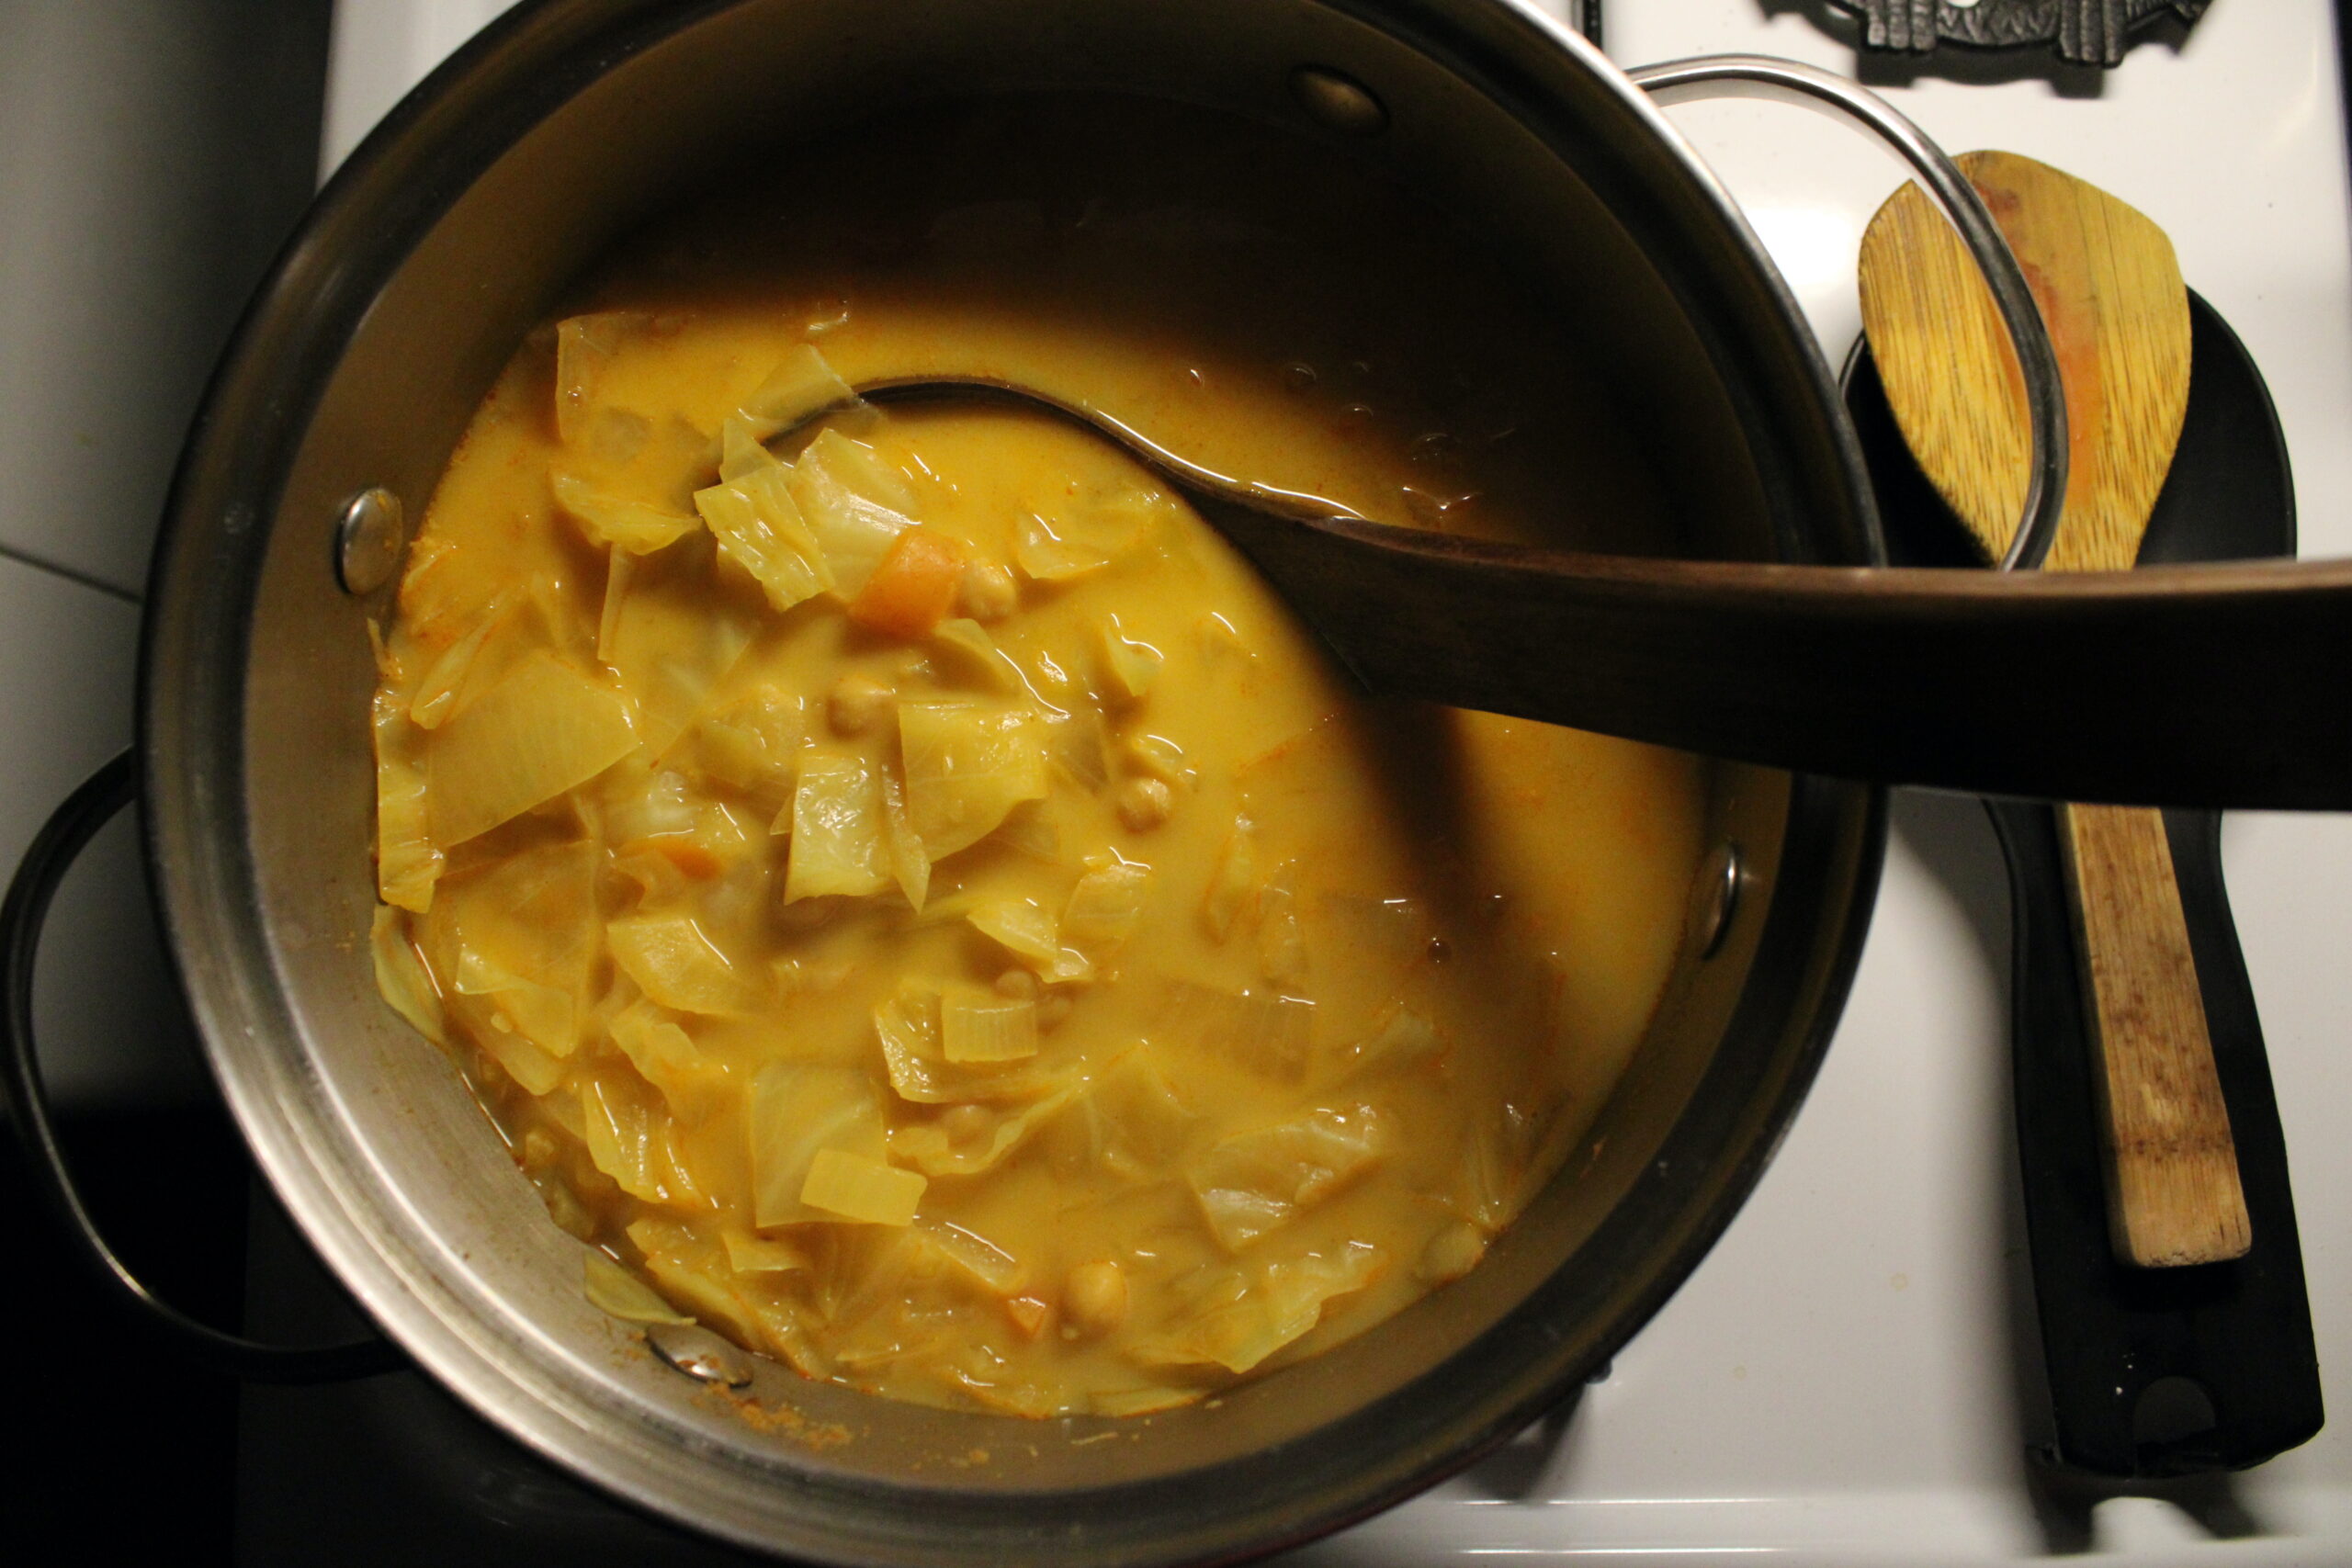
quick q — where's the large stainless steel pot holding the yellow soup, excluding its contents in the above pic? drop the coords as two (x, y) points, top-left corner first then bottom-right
(5, 0), (1928, 1568)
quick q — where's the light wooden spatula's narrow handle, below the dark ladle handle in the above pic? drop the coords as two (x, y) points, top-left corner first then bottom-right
(2061, 807), (2253, 1267)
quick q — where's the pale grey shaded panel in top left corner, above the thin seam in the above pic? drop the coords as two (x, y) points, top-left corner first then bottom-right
(0, 0), (322, 590)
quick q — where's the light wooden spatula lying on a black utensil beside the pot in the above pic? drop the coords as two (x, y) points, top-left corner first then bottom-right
(1860, 152), (2251, 1267)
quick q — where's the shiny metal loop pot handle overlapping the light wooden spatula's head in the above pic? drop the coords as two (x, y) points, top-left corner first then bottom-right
(1625, 54), (2067, 571)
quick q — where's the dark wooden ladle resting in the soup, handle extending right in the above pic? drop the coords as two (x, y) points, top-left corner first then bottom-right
(861, 376), (2352, 811)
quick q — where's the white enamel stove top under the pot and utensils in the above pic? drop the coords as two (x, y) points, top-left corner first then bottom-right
(0, 0), (2352, 1568)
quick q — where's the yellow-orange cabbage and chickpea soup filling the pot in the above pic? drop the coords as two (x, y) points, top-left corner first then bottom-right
(377, 98), (1702, 1416)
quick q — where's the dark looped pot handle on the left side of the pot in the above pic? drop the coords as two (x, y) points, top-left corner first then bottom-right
(0, 752), (404, 1382)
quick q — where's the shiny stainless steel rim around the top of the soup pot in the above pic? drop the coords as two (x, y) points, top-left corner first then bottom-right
(139, 0), (1886, 1561)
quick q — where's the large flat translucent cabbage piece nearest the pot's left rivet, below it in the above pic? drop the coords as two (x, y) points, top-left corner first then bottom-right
(428, 653), (638, 844)
